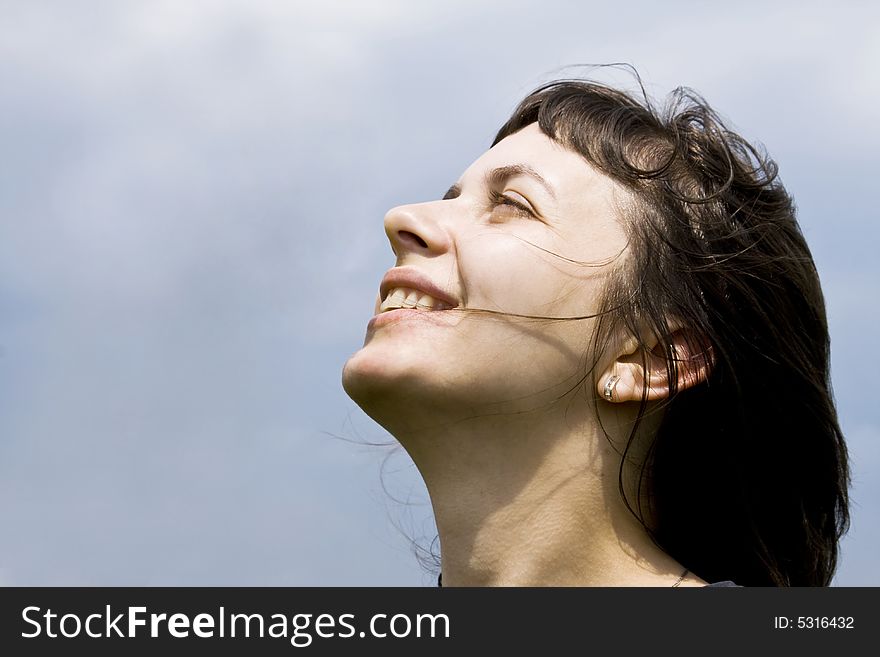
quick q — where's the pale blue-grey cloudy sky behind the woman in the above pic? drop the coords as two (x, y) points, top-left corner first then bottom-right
(0, 0), (880, 586)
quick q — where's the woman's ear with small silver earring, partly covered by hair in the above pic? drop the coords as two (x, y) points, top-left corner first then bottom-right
(598, 328), (713, 403)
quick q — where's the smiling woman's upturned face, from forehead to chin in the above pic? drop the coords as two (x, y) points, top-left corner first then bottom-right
(343, 124), (626, 420)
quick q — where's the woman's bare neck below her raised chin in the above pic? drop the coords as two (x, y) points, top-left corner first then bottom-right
(393, 404), (695, 586)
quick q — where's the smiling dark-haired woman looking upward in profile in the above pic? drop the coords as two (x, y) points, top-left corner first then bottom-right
(343, 81), (849, 587)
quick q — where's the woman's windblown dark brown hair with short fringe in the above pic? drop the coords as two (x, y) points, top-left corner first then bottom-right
(493, 80), (849, 586)
